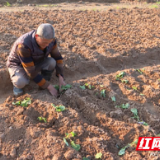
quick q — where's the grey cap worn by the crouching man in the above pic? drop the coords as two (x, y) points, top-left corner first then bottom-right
(36, 23), (55, 39)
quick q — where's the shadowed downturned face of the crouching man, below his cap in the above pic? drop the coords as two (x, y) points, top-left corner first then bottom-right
(35, 35), (55, 50)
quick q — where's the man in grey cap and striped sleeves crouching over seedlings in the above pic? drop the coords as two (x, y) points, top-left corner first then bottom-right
(7, 23), (65, 97)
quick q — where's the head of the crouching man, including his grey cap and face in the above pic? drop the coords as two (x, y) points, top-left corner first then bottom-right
(35, 23), (55, 49)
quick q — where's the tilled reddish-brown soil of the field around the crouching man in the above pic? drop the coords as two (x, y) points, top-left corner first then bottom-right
(0, 1), (160, 160)
